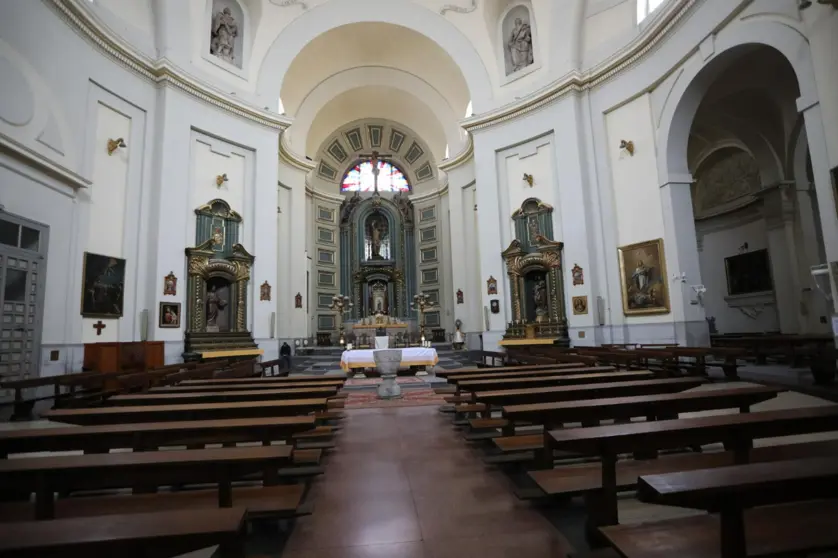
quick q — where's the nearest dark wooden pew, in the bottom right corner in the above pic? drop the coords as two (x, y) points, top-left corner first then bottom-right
(601, 456), (838, 558)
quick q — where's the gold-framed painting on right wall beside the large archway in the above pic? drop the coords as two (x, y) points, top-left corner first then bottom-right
(617, 238), (670, 316)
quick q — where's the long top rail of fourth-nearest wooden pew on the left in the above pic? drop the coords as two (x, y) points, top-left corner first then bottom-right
(45, 399), (328, 425)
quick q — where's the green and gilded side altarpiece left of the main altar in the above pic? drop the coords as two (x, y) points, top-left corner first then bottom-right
(184, 199), (256, 355)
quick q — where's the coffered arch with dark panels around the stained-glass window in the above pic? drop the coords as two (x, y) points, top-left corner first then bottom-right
(315, 118), (437, 193)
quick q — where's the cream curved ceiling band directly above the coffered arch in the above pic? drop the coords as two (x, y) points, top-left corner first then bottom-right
(302, 86), (446, 164)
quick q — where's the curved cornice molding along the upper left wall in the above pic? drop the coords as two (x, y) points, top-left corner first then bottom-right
(50, 0), (292, 130)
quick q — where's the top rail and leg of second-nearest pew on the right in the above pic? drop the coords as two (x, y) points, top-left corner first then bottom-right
(530, 405), (838, 540)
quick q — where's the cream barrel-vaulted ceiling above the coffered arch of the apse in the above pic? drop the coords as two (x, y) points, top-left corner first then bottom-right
(281, 23), (470, 165)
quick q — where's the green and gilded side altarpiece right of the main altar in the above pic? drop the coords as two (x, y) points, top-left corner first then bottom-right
(501, 198), (570, 346)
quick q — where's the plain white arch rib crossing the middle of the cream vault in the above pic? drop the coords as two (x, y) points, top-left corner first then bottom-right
(289, 66), (466, 153)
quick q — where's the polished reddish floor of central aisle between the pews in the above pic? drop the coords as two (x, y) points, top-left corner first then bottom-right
(272, 406), (568, 558)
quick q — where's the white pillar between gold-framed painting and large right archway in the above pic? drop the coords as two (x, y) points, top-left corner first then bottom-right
(660, 175), (710, 346)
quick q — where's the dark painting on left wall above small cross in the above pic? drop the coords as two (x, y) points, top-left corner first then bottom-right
(81, 252), (125, 318)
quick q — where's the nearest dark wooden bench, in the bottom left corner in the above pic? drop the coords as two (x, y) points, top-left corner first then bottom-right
(0, 507), (245, 558)
